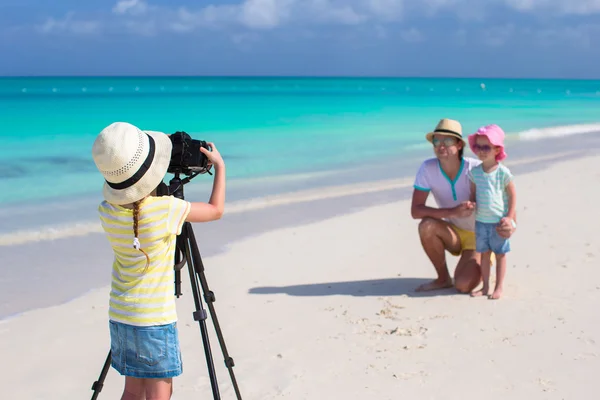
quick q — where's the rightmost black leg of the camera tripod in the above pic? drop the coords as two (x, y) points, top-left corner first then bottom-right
(185, 223), (242, 400)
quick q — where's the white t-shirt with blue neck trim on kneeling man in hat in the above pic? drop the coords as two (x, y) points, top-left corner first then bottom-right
(414, 157), (481, 231)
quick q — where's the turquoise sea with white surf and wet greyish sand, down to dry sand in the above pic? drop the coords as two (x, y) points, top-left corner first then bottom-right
(0, 77), (600, 321)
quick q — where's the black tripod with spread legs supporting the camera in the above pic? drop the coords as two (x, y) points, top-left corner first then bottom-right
(92, 173), (242, 400)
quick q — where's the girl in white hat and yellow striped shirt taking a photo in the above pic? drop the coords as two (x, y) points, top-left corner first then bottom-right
(92, 122), (225, 400)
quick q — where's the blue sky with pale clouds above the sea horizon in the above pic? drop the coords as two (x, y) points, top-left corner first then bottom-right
(0, 0), (600, 78)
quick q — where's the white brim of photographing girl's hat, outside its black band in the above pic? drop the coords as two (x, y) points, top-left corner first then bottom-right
(102, 131), (173, 205)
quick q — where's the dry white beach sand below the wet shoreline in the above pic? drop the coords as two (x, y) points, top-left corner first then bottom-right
(0, 157), (600, 400)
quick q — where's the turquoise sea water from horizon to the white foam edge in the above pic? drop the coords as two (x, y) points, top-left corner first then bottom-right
(0, 77), (600, 233)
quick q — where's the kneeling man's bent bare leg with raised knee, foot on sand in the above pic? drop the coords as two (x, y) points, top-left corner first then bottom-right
(416, 218), (460, 292)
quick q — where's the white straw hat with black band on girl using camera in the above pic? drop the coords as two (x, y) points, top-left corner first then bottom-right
(92, 122), (172, 205)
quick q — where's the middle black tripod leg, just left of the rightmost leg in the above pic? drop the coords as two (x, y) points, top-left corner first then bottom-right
(182, 222), (221, 400)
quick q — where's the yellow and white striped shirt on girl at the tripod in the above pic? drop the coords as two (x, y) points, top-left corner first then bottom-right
(98, 196), (190, 326)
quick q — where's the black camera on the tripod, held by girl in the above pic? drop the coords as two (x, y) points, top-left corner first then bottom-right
(167, 131), (211, 175)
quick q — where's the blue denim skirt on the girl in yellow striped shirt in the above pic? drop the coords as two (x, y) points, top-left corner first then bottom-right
(109, 321), (183, 378)
